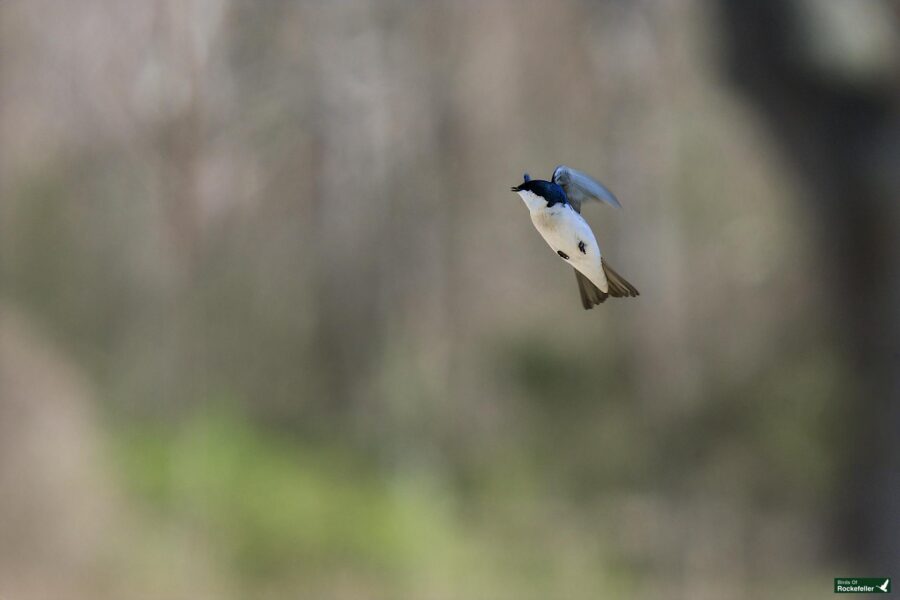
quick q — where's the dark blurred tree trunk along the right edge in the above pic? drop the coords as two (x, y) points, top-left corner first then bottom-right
(719, 0), (900, 573)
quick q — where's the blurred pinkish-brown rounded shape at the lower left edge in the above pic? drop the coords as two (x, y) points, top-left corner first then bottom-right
(0, 308), (113, 598)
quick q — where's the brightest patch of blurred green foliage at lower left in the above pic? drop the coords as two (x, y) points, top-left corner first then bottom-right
(120, 411), (460, 577)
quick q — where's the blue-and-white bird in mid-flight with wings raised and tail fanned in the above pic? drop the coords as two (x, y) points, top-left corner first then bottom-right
(512, 165), (640, 309)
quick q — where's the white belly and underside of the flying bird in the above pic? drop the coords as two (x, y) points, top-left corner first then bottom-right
(531, 204), (609, 292)
